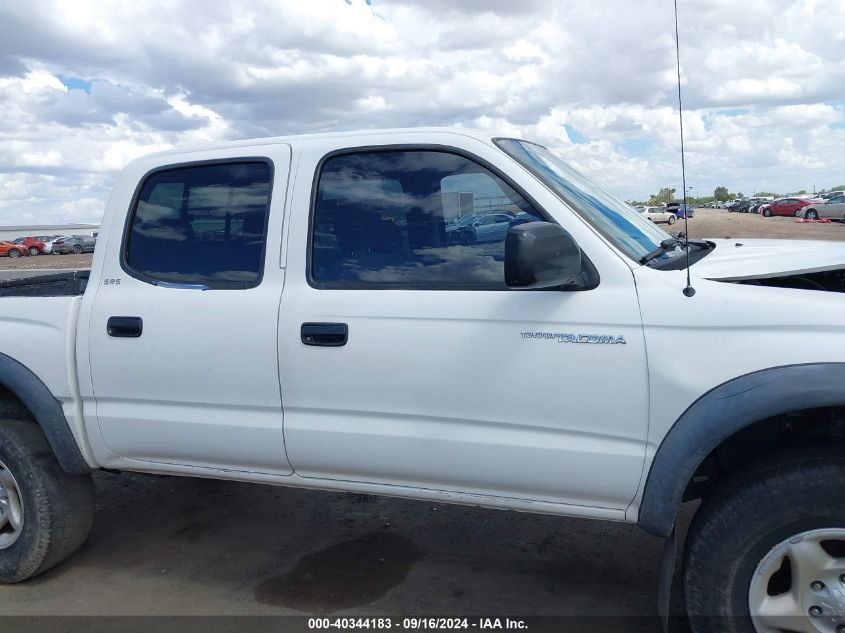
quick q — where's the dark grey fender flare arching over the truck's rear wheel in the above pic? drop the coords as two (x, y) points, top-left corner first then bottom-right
(0, 354), (93, 475)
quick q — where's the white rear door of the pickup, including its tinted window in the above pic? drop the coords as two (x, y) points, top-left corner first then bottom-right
(88, 146), (291, 474)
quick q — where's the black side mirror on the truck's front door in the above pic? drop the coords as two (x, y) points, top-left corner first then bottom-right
(505, 222), (583, 289)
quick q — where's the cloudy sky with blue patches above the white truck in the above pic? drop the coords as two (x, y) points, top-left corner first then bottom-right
(0, 0), (845, 224)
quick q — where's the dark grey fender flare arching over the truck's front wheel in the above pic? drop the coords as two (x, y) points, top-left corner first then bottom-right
(637, 363), (845, 537)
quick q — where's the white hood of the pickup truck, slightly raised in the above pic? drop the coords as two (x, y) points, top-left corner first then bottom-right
(691, 237), (845, 281)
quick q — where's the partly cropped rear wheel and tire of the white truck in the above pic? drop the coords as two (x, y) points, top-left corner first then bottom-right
(0, 419), (94, 583)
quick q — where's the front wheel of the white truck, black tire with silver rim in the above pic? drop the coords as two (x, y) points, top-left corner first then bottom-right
(684, 447), (845, 633)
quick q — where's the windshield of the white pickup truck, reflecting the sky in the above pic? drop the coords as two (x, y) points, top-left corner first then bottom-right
(496, 139), (680, 261)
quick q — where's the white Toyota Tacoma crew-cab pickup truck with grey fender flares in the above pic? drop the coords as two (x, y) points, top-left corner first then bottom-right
(0, 129), (845, 631)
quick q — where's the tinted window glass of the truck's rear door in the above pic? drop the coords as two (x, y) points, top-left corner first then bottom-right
(124, 161), (273, 289)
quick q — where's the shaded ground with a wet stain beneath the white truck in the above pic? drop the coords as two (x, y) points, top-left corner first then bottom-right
(0, 473), (690, 632)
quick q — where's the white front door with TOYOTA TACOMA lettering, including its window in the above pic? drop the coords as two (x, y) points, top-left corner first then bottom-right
(279, 146), (648, 512)
